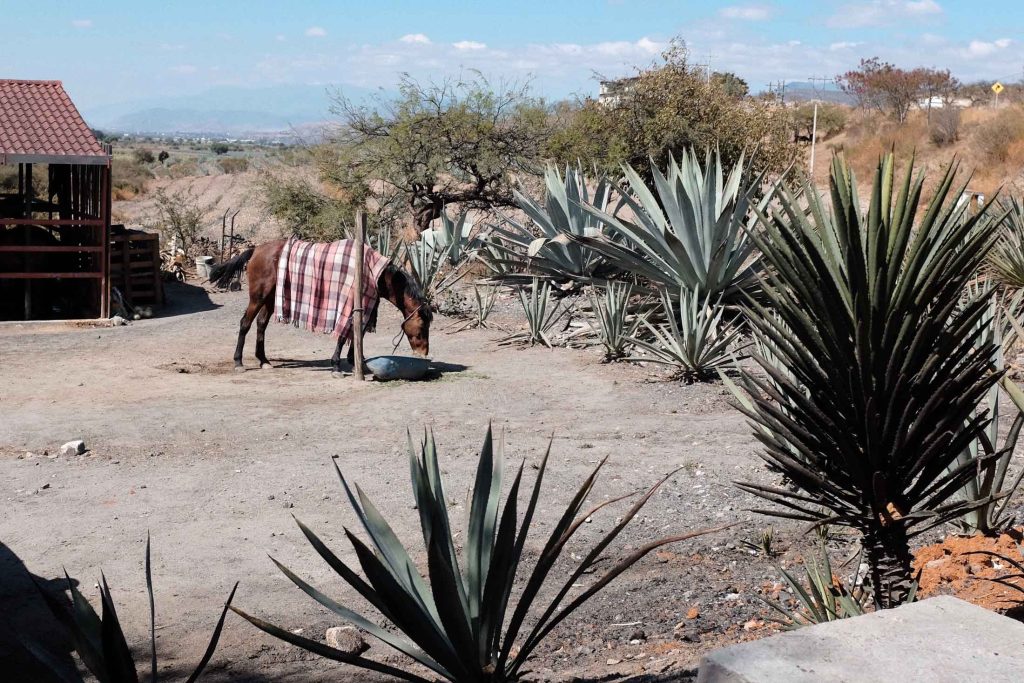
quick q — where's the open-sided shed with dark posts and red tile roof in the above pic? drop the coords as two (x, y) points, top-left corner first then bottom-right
(0, 80), (111, 321)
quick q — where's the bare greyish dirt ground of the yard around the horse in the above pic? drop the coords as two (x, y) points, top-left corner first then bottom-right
(0, 286), (1024, 682)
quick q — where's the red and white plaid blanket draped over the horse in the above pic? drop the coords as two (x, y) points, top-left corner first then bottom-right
(273, 238), (388, 338)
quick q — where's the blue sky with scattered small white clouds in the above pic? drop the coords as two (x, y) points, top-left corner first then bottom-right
(8, 0), (1024, 106)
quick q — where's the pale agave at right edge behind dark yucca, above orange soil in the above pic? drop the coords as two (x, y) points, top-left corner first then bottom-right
(952, 287), (1024, 536)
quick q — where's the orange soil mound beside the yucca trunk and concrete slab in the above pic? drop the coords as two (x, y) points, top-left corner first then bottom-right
(913, 529), (1024, 611)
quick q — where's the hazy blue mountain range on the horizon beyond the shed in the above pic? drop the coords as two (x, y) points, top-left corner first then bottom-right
(82, 85), (380, 137)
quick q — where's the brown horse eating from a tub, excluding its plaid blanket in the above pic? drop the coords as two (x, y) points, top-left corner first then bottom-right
(210, 240), (433, 372)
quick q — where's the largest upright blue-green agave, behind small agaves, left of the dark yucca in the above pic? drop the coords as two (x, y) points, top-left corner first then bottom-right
(570, 150), (771, 303)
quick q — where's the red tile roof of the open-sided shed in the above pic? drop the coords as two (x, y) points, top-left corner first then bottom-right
(0, 80), (109, 163)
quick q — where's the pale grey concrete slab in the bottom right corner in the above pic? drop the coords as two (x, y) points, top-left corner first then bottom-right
(697, 596), (1024, 683)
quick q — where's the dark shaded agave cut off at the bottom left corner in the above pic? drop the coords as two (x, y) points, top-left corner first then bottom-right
(40, 538), (239, 683)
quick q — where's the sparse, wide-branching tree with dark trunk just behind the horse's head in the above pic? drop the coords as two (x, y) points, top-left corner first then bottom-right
(321, 75), (550, 230)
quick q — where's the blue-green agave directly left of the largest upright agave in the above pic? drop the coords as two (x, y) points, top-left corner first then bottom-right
(484, 166), (615, 283)
